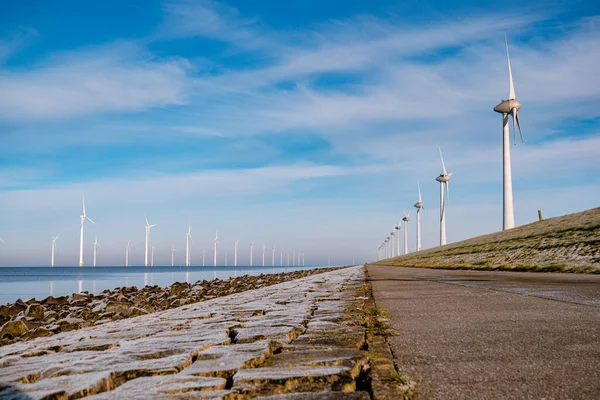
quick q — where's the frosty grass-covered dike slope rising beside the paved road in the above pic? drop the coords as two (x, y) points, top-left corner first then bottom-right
(375, 208), (600, 273)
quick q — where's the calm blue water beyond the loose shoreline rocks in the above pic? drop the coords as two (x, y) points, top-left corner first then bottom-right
(0, 267), (314, 304)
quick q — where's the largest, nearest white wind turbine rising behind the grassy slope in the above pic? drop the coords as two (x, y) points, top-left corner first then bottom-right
(494, 36), (524, 230)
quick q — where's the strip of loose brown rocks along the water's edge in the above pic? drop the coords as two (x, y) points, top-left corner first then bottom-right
(0, 268), (338, 346)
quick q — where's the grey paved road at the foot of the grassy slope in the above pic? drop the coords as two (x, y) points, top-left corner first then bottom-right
(368, 266), (600, 399)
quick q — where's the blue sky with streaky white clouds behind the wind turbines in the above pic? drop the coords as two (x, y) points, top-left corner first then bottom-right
(0, 0), (600, 266)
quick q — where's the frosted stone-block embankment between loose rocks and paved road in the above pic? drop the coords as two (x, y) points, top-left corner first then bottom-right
(0, 267), (403, 400)
